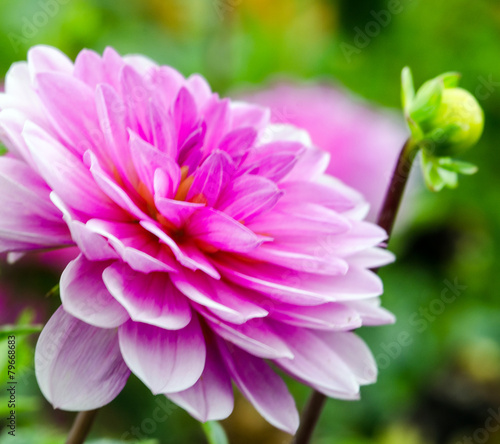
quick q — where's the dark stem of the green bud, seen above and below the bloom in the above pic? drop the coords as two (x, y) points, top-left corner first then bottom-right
(292, 138), (418, 444)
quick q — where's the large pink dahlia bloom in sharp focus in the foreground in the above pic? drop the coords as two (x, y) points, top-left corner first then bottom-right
(0, 46), (392, 433)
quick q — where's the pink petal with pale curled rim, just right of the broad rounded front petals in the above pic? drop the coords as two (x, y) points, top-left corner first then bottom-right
(172, 270), (268, 324)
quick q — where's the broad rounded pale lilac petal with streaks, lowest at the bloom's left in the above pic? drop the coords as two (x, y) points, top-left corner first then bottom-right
(35, 307), (130, 411)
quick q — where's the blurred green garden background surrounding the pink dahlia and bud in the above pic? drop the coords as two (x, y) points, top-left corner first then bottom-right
(0, 0), (500, 444)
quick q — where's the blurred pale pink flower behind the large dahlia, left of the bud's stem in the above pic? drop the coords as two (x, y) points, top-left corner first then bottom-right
(243, 83), (408, 221)
